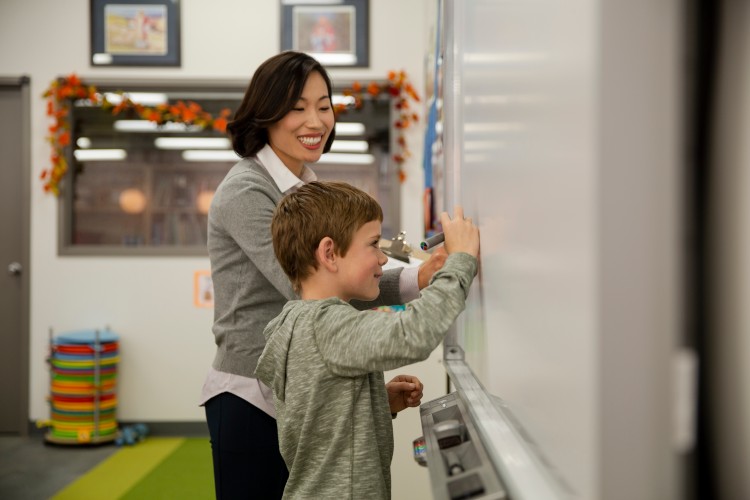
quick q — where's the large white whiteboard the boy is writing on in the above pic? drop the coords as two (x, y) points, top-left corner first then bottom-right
(433, 0), (682, 500)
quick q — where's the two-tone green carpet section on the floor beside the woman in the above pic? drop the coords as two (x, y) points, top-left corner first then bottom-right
(52, 437), (214, 500)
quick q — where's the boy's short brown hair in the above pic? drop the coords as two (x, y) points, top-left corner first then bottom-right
(271, 181), (383, 292)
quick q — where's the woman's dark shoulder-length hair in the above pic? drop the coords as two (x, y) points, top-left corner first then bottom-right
(227, 51), (336, 158)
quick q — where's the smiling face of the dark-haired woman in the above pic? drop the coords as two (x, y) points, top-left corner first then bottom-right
(268, 71), (335, 177)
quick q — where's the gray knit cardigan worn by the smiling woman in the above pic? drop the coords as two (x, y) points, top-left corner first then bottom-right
(208, 158), (401, 377)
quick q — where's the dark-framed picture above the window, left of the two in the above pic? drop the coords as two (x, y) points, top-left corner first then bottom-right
(91, 0), (180, 66)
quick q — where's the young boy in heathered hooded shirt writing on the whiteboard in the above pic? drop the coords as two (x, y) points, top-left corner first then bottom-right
(255, 182), (479, 499)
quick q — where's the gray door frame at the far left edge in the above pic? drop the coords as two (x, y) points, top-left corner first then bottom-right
(0, 75), (31, 437)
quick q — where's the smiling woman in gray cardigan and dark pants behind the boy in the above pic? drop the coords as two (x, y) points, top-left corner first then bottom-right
(202, 51), (445, 499)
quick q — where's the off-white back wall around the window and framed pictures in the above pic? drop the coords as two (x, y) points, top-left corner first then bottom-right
(0, 0), (445, 496)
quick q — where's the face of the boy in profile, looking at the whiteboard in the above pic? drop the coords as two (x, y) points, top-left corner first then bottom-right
(337, 220), (388, 302)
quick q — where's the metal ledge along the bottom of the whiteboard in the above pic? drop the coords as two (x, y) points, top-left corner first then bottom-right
(444, 359), (573, 500)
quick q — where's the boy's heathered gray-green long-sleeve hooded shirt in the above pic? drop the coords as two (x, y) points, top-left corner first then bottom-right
(256, 253), (477, 500)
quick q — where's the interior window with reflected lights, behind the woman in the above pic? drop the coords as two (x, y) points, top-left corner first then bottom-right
(60, 83), (400, 255)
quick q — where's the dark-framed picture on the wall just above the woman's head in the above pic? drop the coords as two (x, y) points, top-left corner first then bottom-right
(281, 0), (370, 67)
